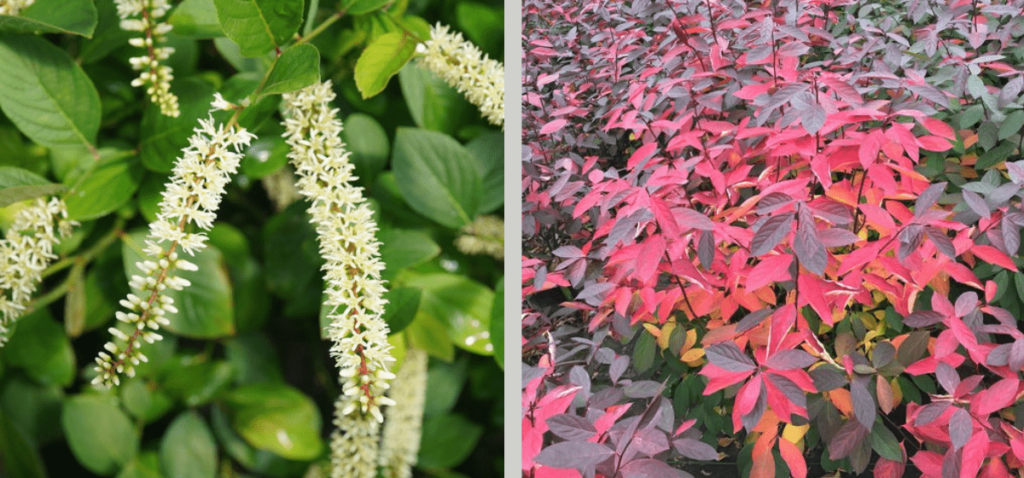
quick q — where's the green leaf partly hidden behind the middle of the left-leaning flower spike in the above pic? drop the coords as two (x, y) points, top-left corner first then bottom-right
(122, 231), (234, 339)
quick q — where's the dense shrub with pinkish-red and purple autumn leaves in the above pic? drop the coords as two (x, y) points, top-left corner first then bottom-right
(522, 0), (1024, 478)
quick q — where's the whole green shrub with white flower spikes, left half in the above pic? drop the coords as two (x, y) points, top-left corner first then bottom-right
(0, 0), (504, 478)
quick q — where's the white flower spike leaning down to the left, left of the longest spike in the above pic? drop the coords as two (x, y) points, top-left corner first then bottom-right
(93, 102), (254, 387)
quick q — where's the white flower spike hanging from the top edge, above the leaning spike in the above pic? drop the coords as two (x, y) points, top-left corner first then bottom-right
(116, 0), (180, 118)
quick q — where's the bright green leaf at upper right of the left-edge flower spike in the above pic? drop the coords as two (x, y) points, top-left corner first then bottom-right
(65, 148), (144, 221)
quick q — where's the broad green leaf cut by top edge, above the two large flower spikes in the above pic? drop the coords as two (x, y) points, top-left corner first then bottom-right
(213, 0), (303, 57)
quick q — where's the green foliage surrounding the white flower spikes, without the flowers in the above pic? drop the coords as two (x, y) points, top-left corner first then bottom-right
(0, 0), (504, 478)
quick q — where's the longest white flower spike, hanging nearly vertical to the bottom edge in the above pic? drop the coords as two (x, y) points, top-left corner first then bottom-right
(284, 82), (394, 478)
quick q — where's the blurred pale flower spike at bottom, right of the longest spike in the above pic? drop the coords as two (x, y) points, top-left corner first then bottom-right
(380, 349), (427, 478)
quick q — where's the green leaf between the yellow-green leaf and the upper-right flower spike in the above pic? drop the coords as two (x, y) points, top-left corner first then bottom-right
(398, 63), (476, 135)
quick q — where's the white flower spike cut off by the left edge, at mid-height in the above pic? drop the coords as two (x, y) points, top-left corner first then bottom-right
(0, 198), (78, 345)
